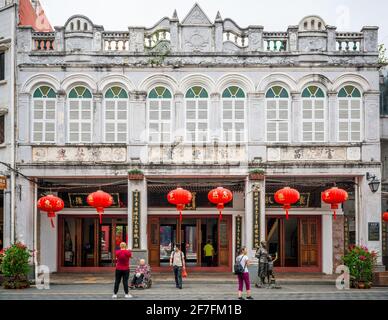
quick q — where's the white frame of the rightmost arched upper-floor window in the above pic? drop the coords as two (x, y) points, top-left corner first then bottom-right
(337, 84), (364, 143)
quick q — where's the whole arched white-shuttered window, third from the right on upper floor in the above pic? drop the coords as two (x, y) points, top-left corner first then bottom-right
(265, 86), (290, 142)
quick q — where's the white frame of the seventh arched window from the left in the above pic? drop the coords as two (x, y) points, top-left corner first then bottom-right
(264, 84), (292, 144)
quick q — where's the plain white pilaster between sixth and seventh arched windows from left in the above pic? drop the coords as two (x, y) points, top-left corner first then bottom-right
(246, 93), (266, 142)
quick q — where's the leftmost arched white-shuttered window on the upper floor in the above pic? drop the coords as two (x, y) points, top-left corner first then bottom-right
(32, 86), (57, 142)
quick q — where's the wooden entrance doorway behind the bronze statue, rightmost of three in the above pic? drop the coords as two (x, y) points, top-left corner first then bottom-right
(266, 216), (321, 272)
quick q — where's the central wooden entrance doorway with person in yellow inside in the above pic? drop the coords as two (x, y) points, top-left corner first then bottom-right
(148, 216), (232, 271)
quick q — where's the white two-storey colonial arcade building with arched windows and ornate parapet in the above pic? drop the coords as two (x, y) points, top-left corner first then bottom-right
(10, 4), (381, 274)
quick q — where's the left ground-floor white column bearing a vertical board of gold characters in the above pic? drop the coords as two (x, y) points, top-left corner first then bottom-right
(128, 179), (148, 260)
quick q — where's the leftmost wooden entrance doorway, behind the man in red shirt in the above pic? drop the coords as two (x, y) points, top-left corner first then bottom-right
(58, 215), (128, 271)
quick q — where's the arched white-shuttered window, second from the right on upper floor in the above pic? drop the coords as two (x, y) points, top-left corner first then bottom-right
(302, 86), (326, 142)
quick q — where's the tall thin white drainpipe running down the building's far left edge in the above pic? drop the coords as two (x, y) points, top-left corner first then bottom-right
(10, 2), (18, 244)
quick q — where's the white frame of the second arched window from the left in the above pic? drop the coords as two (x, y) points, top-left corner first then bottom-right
(66, 85), (94, 144)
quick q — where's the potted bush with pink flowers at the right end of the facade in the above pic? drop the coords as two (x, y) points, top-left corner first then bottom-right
(342, 245), (377, 289)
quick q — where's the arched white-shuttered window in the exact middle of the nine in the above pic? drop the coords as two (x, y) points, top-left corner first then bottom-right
(185, 86), (209, 142)
